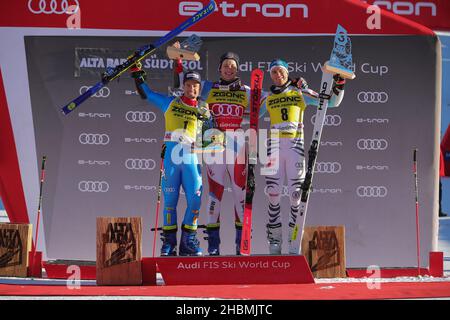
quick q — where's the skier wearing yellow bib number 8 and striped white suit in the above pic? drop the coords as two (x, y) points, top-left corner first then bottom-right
(260, 59), (345, 255)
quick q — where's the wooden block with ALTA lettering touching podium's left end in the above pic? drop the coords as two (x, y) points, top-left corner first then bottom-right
(96, 217), (142, 285)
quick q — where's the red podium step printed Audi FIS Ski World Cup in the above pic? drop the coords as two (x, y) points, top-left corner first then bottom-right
(142, 255), (314, 285)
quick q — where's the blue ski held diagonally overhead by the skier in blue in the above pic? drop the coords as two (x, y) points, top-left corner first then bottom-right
(61, 0), (216, 114)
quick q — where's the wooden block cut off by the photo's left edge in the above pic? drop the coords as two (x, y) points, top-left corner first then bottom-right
(0, 223), (33, 277)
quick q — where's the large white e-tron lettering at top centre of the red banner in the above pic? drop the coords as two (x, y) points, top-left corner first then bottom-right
(178, 1), (309, 19)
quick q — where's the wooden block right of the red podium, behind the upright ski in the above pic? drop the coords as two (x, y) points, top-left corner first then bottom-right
(302, 226), (346, 278)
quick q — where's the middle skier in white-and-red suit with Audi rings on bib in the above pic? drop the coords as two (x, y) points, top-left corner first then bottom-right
(175, 52), (250, 255)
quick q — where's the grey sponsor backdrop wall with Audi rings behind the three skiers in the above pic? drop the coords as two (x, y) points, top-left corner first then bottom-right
(25, 36), (439, 267)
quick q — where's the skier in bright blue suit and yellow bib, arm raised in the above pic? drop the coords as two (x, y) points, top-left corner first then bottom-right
(132, 66), (212, 256)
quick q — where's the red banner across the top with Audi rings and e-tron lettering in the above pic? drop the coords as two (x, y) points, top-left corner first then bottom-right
(0, 0), (436, 35)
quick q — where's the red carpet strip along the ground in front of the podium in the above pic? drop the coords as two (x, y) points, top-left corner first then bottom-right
(0, 282), (450, 300)
